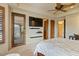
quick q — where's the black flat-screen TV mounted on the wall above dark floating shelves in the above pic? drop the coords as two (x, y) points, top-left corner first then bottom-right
(29, 16), (43, 27)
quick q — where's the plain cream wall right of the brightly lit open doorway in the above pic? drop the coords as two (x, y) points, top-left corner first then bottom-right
(66, 13), (79, 38)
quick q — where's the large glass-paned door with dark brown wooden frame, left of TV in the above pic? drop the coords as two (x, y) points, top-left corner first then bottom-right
(11, 12), (25, 47)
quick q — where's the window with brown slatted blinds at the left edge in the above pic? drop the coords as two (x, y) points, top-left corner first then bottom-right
(0, 6), (5, 43)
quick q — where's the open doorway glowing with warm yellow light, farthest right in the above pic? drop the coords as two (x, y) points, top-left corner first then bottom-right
(58, 20), (65, 38)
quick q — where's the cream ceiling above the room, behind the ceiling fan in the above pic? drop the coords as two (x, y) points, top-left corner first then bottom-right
(9, 3), (79, 17)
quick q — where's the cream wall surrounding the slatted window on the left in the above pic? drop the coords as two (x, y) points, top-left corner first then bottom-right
(0, 4), (9, 55)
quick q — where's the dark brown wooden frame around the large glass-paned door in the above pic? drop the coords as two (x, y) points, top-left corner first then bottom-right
(11, 12), (26, 48)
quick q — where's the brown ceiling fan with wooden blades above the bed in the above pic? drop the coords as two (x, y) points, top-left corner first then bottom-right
(48, 3), (75, 13)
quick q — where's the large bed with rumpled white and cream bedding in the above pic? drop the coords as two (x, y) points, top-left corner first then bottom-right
(34, 38), (79, 56)
